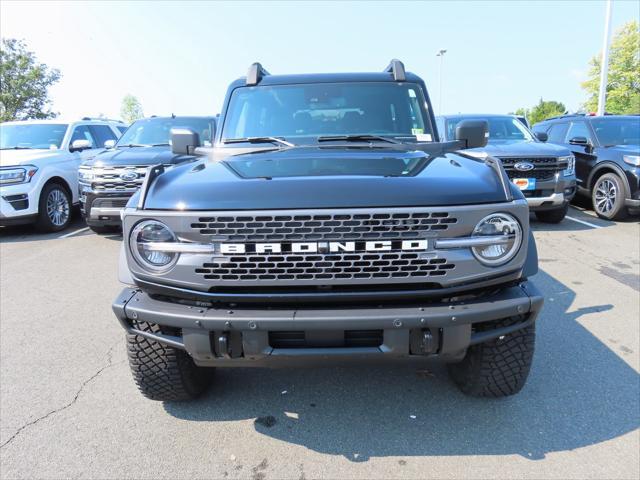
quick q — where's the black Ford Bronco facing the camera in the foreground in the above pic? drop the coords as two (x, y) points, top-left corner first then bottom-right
(113, 60), (543, 400)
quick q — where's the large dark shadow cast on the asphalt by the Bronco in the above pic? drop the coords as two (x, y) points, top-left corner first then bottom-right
(164, 272), (640, 461)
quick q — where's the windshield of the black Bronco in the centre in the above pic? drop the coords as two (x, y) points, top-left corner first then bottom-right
(222, 82), (432, 143)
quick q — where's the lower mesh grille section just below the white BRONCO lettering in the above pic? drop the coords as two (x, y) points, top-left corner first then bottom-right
(195, 251), (455, 282)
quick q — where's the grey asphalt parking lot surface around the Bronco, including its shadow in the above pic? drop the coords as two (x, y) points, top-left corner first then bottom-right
(0, 208), (640, 480)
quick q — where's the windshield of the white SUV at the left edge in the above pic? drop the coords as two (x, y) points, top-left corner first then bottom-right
(0, 123), (68, 149)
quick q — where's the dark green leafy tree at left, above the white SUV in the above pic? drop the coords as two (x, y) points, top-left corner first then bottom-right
(0, 38), (60, 122)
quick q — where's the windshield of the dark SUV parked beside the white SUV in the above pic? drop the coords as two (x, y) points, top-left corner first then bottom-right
(117, 117), (218, 147)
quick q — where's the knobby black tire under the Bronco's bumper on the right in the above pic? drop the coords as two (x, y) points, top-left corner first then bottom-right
(448, 318), (535, 397)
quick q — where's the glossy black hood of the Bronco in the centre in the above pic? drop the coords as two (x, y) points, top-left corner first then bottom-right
(145, 144), (506, 210)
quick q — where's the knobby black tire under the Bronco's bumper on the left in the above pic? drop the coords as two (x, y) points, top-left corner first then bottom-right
(127, 322), (212, 401)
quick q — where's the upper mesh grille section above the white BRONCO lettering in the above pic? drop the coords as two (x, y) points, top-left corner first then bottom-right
(191, 212), (458, 242)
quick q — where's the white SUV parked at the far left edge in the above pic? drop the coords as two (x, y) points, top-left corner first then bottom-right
(0, 118), (126, 232)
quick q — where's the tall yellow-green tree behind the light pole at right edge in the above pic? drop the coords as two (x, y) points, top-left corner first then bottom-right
(582, 21), (640, 115)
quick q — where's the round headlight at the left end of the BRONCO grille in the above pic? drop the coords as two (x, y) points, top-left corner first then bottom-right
(129, 220), (178, 272)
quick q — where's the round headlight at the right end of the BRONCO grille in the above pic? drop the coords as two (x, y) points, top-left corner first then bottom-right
(471, 213), (522, 267)
